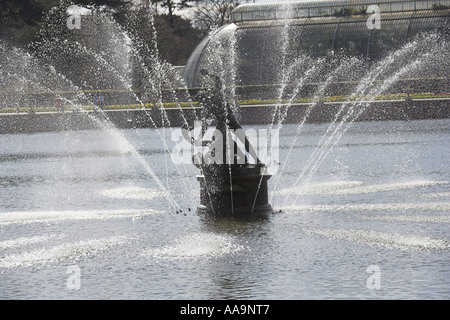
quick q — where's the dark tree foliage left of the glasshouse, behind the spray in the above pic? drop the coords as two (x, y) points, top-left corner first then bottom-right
(0, 0), (203, 65)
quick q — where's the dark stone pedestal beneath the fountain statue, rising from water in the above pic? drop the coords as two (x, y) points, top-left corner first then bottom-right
(197, 164), (273, 216)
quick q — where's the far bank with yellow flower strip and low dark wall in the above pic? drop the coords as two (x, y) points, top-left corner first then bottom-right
(0, 98), (450, 134)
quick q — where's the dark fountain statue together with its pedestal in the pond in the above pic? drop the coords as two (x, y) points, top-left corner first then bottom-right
(187, 69), (272, 216)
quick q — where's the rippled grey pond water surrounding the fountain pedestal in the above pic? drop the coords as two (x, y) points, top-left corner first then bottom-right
(0, 120), (450, 299)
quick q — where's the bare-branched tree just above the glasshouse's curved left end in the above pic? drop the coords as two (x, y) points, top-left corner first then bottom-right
(192, 0), (242, 32)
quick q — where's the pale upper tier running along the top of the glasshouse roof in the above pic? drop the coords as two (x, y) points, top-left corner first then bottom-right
(232, 0), (450, 23)
